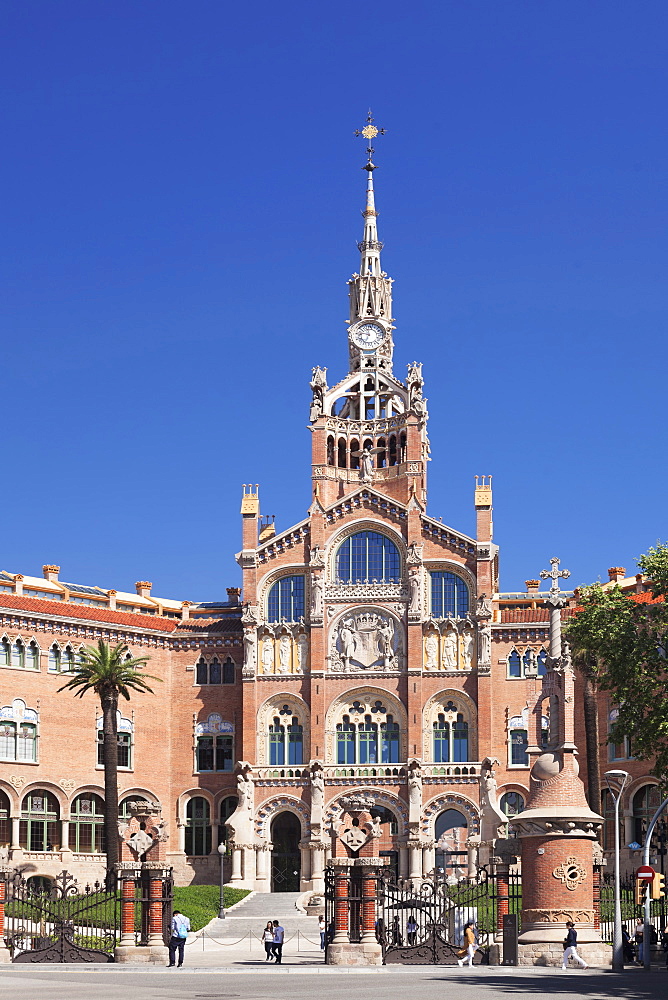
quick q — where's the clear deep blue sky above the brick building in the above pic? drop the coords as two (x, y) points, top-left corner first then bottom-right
(0, 0), (668, 600)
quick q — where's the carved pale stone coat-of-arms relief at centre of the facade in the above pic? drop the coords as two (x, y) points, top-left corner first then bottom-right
(329, 607), (404, 673)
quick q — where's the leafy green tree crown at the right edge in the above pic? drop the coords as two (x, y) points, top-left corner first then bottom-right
(566, 544), (668, 785)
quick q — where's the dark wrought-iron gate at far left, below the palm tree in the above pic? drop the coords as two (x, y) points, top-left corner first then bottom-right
(5, 871), (120, 963)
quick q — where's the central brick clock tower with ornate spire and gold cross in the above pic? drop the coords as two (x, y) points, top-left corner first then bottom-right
(310, 112), (429, 508)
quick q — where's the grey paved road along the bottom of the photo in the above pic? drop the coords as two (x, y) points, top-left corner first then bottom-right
(0, 966), (668, 1000)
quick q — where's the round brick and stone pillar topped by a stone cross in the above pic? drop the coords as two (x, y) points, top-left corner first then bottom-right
(510, 558), (611, 966)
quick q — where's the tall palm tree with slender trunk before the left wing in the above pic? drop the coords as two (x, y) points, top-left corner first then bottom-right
(58, 639), (160, 884)
